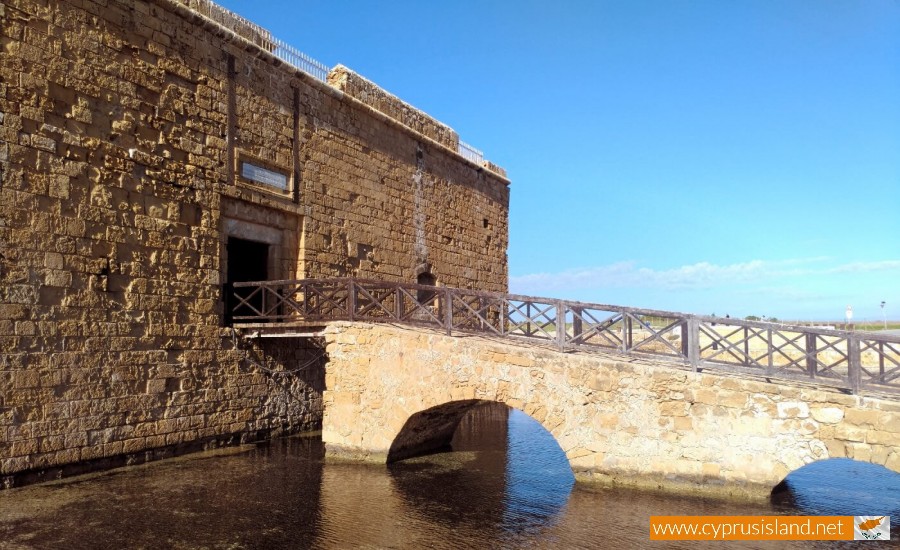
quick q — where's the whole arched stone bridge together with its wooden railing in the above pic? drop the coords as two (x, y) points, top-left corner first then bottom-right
(235, 279), (900, 500)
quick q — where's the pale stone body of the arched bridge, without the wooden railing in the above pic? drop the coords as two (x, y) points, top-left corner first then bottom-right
(322, 322), (900, 497)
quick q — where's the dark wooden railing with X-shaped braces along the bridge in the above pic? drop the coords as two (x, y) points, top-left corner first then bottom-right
(232, 278), (900, 393)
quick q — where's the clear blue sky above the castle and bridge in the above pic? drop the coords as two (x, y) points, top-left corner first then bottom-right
(213, 0), (900, 319)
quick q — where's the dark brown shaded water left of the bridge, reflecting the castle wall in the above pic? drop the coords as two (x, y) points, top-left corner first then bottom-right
(0, 439), (322, 549)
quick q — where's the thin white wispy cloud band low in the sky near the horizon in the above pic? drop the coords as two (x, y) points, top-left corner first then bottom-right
(510, 257), (900, 293)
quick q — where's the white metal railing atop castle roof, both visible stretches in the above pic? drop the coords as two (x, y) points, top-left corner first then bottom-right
(178, 0), (484, 166)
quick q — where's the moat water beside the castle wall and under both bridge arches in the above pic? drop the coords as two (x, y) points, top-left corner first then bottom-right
(0, 406), (900, 549)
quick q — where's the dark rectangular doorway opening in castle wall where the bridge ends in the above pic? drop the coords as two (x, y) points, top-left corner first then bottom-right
(225, 237), (269, 326)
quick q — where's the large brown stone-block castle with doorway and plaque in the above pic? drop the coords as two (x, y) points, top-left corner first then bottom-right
(0, 0), (509, 486)
